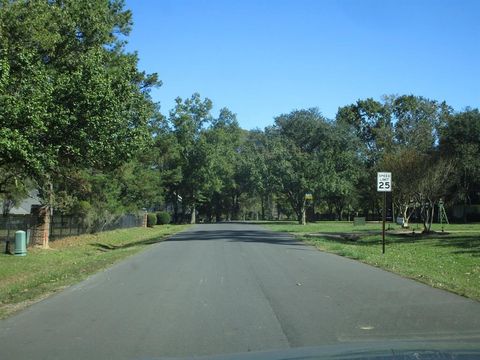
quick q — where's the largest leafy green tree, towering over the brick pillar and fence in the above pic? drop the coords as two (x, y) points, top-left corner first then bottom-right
(0, 0), (160, 245)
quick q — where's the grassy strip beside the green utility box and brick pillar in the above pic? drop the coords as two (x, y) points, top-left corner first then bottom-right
(0, 225), (188, 318)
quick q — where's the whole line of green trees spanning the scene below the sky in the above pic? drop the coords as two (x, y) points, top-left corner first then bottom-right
(0, 0), (480, 231)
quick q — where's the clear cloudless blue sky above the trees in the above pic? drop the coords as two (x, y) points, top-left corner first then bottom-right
(126, 0), (480, 129)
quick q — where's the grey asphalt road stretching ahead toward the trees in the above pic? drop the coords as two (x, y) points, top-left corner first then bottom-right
(0, 224), (480, 360)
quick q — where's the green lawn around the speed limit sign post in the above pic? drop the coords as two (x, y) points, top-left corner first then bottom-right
(264, 222), (480, 300)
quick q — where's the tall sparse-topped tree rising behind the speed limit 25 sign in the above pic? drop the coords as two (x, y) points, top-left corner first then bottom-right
(336, 95), (451, 221)
